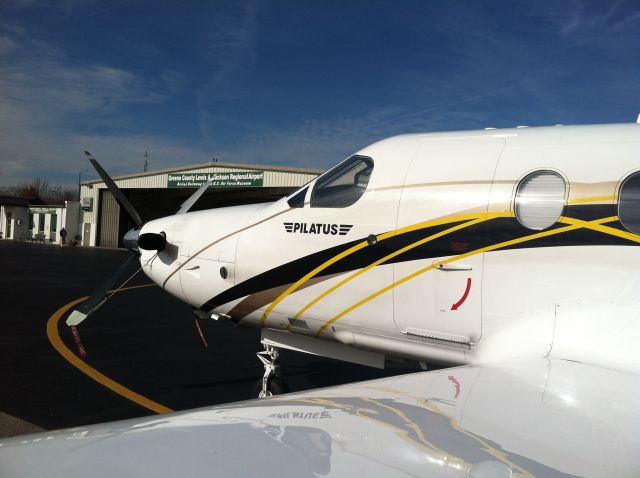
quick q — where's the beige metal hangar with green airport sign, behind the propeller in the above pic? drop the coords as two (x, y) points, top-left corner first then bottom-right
(79, 163), (324, 247)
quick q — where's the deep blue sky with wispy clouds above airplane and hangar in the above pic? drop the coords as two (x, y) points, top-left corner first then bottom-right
(0, 0), (640, 186)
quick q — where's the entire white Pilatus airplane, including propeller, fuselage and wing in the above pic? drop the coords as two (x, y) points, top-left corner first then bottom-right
(0, 124), (640, 478)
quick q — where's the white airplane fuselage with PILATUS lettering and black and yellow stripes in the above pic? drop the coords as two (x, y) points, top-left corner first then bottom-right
(140, 124), (640, 372)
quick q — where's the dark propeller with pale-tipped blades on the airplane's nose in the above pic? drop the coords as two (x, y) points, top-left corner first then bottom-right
(66, 151), (213, 326)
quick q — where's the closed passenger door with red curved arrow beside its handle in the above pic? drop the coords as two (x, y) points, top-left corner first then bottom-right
(394, 137), (504, 345)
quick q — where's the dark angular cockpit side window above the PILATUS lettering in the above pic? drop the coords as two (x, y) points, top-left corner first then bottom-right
(311, 156), (373, 208)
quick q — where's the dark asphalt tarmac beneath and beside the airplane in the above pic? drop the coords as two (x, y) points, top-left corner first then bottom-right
(0, 240), (419, 436)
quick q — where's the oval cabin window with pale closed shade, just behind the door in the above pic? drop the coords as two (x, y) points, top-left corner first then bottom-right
(514, 171), (567, 231)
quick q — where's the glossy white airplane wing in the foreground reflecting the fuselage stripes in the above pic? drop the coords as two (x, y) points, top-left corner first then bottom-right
(0, 359), (640, 478)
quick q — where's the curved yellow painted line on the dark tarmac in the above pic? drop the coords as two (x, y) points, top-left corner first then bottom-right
(47, 284), (173, 413)
